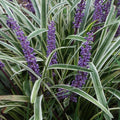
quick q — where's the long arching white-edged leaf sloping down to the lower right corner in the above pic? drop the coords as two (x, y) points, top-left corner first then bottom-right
(52, 85), (113, 118)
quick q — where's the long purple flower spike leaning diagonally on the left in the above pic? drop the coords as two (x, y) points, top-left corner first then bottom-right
(7, 17), (40, 81)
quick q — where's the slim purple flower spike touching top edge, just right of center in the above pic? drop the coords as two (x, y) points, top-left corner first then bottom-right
(73, 0), (85, 34)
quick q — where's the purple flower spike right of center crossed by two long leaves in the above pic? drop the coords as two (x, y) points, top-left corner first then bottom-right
(57, 33), (93, 102)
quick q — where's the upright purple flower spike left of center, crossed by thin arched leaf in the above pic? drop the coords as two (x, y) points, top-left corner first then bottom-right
(47, 21), (57, 65)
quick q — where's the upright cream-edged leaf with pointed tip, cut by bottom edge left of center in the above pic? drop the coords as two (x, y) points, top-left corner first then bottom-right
(34, 95), (43, 120)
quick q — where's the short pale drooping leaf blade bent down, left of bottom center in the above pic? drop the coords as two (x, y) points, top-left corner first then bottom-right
(31, 79), (42, 103)
